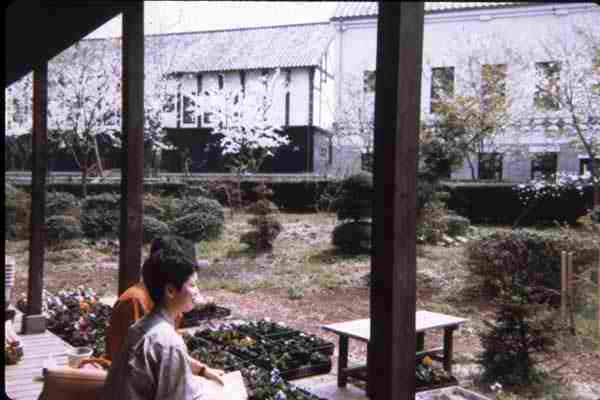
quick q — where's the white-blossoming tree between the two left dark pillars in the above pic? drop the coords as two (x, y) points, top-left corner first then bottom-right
(48, 40), (121, 196)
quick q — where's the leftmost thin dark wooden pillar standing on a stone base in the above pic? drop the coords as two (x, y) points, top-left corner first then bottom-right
(22, 62), (48, 333)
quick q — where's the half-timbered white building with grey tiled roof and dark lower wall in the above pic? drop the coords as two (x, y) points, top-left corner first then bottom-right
(147, 23), (334, 173)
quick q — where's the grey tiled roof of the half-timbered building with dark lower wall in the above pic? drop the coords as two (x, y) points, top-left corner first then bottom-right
(159, 22), (334, 72)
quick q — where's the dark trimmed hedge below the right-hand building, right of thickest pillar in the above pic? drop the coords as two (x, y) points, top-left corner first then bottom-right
(443, 182), (592, 225)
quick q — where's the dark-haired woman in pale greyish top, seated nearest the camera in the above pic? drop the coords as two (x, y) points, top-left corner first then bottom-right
(100, 239), (223, 400)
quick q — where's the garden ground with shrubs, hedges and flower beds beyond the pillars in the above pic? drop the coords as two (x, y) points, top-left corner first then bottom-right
(5, 173), (600, 399)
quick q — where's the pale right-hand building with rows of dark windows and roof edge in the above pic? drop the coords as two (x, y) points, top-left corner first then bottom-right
(331, 2), (600, 181)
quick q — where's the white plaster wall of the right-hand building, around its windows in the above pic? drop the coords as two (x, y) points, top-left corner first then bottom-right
(332, 3), (600, 179)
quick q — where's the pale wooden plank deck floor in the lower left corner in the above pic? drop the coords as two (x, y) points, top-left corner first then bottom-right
(4, 313), (71, 400)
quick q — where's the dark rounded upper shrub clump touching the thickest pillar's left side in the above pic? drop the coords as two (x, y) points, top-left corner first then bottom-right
(335, 172), (373, 221)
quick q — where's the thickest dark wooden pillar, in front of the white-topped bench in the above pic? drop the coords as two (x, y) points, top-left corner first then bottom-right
(368, 2), (424, 400)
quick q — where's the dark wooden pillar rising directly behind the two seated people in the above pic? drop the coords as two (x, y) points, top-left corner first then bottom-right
(119, 1), (144, 294)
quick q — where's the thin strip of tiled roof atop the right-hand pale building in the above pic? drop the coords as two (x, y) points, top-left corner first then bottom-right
(332, 1), (526, 19)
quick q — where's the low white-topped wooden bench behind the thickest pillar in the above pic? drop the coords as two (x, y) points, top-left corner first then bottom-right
(321, 311), (467, 387)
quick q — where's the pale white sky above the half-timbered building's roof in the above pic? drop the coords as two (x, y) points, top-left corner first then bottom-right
(87, 1), (336, 38)
